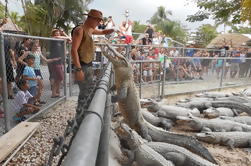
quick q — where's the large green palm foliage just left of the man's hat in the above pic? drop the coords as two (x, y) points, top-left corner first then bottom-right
(17, 0), (92, 36)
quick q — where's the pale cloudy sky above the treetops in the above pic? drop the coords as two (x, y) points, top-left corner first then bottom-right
(89, 0), (216, 30)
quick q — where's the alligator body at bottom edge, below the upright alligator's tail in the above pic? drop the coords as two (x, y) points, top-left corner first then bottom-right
(146, 142), (216, 166)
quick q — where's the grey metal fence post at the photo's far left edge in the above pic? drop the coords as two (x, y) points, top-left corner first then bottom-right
(0, 33), (11, 132)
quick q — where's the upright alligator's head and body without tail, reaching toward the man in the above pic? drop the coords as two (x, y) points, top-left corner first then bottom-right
(101, 45), (151, 140)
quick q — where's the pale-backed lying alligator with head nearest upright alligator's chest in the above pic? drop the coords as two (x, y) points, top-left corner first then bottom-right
(147, 101), (200, 120)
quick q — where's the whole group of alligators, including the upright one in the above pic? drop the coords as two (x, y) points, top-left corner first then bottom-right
(102, 45), (251, 166)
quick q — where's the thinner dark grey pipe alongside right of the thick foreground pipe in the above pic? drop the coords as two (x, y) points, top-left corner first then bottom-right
(96, 94), (112, 166)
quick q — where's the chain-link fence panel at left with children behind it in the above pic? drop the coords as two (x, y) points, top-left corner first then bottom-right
(0, 33), (67, 135)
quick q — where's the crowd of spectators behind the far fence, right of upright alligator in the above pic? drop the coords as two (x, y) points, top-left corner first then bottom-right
(109, 46), (251, 82)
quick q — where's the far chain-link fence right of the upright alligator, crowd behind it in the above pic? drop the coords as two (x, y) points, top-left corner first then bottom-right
(93, 44), (251, 98)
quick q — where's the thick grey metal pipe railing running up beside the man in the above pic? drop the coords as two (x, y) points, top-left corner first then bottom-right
(62, 64), (111, 166)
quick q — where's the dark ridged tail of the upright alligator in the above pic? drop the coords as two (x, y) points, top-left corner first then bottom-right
(146, 122), (217, 164)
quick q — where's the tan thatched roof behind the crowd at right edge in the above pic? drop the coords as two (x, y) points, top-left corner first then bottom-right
(207, 33), (251, 48)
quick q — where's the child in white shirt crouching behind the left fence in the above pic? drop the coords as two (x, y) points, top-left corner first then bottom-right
(13, 79), (39, 121)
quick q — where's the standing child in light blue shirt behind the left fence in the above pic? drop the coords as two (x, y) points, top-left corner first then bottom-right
(23, 54), (41, 106)
